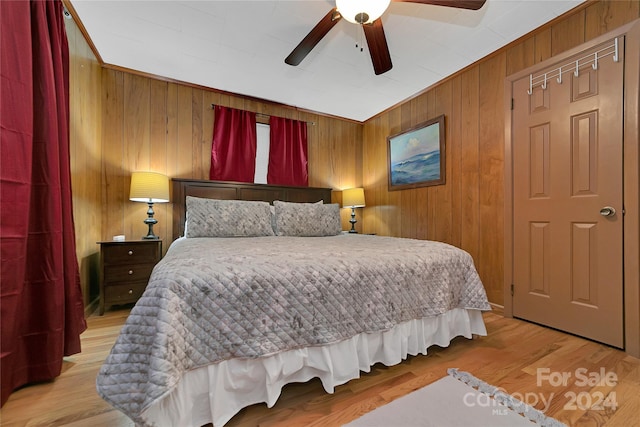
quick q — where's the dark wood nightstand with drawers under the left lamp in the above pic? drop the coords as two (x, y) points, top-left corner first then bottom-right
(98, 240), (162, 316)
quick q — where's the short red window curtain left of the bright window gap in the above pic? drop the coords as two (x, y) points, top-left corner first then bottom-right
(209, 105), (257, 182)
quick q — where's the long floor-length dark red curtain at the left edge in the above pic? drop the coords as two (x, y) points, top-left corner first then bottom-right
(0, 0), (86, 405)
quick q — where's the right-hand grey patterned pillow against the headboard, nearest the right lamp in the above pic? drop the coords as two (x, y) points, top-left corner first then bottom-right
(273, 200), (342, 237)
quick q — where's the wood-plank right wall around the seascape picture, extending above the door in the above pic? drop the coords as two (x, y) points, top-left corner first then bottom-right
(363, 0), (640, 305)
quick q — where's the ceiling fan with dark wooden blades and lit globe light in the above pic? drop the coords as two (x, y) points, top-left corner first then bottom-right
(284, 0), (486, 74)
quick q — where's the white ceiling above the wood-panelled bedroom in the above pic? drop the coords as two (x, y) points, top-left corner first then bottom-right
(71, 0), (583, 122)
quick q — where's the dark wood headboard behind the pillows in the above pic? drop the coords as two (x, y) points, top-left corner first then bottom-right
(171, 178), (331, 240)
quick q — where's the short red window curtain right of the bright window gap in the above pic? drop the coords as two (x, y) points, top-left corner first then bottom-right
(267, 116), (309, 187)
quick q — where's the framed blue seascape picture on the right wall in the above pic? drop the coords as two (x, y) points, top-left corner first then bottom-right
(387, 114), (446, 191)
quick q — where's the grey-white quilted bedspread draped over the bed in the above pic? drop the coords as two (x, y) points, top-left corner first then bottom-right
(97, 234), (490, 424)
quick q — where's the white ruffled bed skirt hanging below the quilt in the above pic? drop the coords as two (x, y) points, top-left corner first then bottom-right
(142, 309), (487, 427)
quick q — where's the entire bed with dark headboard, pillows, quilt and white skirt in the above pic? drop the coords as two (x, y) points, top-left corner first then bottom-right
(97, 180), (490, 427)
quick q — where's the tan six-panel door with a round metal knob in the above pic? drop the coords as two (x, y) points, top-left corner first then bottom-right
(512, 38), (624, 347)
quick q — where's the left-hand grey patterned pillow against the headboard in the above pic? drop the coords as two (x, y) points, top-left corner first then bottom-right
(185, 196), (274, 237)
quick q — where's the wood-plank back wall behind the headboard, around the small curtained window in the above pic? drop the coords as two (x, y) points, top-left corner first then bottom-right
(101, 69), (362, 254)
